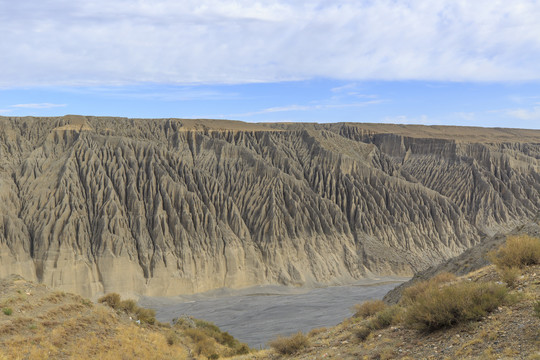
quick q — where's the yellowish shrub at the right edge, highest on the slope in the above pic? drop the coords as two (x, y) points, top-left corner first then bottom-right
(488, 235), (540, 268)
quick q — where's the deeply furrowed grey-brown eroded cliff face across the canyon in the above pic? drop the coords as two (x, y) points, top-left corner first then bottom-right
(0, 116), (540, 296)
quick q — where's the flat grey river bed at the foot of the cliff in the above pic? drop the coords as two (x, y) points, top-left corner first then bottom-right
(139, 278), (405, 348)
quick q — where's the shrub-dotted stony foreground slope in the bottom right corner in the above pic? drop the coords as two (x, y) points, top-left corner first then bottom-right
(244, 229), (540, 360)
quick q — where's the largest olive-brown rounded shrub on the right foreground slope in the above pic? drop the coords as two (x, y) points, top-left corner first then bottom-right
(404, 282), (508, 331)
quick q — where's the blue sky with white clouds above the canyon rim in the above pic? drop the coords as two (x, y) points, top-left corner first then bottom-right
(0, 0), (540, 129)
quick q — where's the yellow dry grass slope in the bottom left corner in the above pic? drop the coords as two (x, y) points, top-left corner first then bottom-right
(0, 279), (192, 360)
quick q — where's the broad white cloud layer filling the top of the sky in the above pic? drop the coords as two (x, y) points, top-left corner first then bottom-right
(0, 0), (540, 87)
